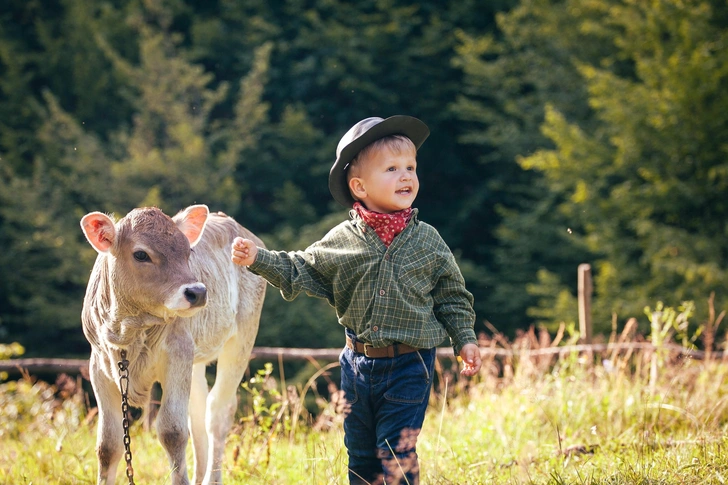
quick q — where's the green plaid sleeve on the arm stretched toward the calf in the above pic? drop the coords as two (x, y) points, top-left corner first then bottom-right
(248, 243), (334, 306)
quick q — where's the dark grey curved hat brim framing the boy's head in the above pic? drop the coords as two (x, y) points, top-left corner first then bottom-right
(329, 115), (430, 207)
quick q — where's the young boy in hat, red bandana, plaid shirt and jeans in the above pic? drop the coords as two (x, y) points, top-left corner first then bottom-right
(232, 116), (481, 484)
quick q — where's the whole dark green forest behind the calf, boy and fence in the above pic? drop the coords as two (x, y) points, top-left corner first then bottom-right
(0, 0), (728, 357)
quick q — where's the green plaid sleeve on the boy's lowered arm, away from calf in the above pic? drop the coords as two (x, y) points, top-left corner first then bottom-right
(432, 250), (478, 355)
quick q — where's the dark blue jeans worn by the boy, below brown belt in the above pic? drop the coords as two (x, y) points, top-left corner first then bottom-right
(339, 336), (435, 485)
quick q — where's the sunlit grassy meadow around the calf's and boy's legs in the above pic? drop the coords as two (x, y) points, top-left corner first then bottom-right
(0, 320), (728, 485)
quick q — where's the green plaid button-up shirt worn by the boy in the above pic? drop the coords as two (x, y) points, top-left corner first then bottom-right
(249, 209), (477, 354)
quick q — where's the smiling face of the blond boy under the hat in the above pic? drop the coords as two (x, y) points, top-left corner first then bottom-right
(349, 147), (420, 214)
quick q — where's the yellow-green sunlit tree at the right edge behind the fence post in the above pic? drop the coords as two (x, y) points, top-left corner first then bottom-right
(523, 1), (728, 326)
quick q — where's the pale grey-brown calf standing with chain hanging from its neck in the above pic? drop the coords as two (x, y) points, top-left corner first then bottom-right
(81, 205), (265, 485)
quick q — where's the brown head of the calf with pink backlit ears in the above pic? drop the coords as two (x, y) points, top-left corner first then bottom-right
(81, 205), (209, 320)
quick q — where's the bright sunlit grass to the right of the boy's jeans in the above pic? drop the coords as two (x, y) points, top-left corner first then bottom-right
(419, 359), (728, 484)
